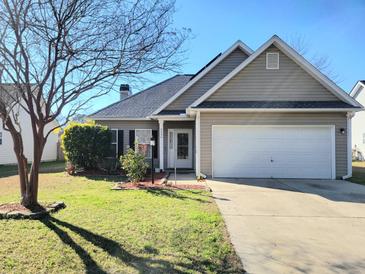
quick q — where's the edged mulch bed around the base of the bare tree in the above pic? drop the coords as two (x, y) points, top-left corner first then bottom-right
(0, 202), (66, 219)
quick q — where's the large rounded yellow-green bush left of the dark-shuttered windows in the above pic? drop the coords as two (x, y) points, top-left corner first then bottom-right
(61, 122), (111, 170)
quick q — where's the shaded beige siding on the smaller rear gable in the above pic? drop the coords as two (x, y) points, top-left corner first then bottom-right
(166, 49), (248, 110)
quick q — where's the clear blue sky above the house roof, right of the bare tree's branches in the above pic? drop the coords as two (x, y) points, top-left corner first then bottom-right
(90, 0), (365, 111)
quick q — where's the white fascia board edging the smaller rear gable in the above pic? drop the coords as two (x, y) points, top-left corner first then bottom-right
(152, 40), (253, 115)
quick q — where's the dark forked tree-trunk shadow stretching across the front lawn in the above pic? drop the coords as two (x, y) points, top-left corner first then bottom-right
(41, 216), (185, 273)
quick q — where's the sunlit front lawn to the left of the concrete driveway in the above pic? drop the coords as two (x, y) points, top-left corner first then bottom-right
(0, 173), (242, 273)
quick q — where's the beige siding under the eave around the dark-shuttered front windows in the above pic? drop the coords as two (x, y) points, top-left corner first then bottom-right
(96, 120), (159, 167)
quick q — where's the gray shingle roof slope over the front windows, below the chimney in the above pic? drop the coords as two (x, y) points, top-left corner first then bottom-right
(90, 74), (192, 120)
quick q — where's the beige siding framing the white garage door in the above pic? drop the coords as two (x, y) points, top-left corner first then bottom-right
(200, 112), (347, 177)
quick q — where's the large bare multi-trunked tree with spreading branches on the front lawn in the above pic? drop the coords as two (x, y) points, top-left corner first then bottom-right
(0, 0), (189, 208)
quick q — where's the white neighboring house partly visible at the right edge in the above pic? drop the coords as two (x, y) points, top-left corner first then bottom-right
(350, 80), (365, 161)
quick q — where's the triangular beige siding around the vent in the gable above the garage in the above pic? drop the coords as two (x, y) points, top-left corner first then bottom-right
(207, 45), (339, 101)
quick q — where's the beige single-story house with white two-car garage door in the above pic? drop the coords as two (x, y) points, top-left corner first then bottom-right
(90, 35), (362, 179)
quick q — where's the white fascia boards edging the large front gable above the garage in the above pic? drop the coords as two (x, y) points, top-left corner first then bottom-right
(189, 35), (362, 107)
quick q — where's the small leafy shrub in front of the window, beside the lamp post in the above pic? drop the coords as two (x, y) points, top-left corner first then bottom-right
(120, 149), (148, 183)
